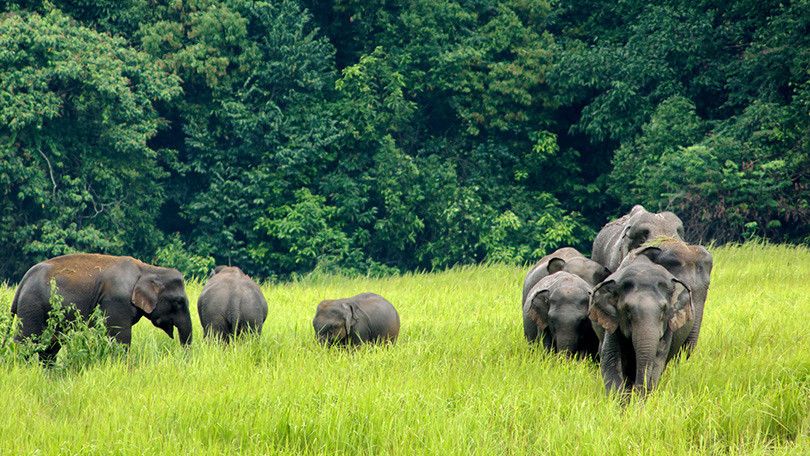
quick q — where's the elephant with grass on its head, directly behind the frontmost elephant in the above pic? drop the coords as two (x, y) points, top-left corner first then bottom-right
(620, 238), (713, 353)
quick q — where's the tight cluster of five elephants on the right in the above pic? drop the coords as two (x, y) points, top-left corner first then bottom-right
(522, 206), (712, 395)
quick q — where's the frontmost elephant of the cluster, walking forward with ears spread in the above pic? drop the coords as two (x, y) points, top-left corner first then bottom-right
(589, 255), (694, 395)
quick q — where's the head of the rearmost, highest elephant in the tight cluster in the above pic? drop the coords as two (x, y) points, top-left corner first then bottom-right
(620, 204), (684, 258)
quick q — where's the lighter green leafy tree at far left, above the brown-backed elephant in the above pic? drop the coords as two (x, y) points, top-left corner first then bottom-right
(0, 11), (179, 276)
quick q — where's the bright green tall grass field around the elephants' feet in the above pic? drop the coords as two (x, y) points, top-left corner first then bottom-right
(0, 245), (810, 455)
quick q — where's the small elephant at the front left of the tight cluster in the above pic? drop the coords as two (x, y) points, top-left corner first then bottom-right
(523, 271), (599, 357)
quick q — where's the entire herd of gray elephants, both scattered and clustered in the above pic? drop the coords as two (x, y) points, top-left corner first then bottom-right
(11, 206), (712, 394)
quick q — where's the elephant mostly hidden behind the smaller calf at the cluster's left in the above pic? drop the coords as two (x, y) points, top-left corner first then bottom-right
(521, 247), (610, 305)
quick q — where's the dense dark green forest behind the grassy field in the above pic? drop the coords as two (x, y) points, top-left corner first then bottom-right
(0, 0), (810, 280)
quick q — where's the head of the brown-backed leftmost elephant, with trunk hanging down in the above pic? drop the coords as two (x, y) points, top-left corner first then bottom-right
(132, 263), (191, 345)
